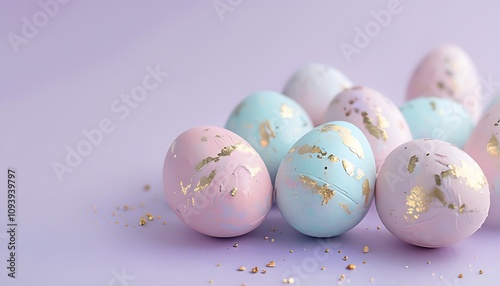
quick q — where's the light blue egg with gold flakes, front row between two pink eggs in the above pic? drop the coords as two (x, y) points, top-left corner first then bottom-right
(275, 121), (376, 237)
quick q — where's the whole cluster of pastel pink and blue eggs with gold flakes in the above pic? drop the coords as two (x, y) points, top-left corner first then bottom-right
(163, 45), (500, 247)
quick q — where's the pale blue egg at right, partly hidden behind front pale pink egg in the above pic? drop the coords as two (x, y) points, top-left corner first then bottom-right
(400, 97), (474, 148)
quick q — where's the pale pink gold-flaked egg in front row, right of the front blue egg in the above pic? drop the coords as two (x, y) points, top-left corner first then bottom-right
(375, 139), (490, 248)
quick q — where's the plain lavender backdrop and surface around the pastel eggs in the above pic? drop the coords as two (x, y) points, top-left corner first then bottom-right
(0, 0), (500, 286)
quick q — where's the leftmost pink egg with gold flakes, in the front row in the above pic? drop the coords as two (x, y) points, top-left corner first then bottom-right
(163, 126), (273, 237)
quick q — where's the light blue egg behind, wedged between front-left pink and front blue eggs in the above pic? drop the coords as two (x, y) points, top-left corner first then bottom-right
(226, 91), (313, 182)
